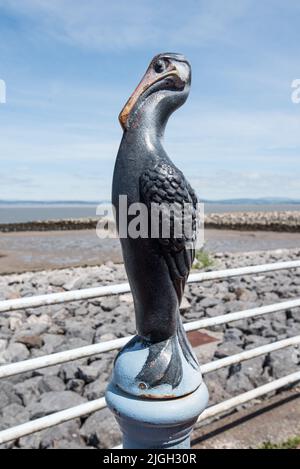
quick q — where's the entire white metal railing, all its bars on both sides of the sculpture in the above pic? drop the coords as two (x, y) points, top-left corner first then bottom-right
(0, 261), (300, 444)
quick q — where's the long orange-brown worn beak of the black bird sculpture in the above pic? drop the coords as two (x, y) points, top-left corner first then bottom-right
(119, 65), (180, 130)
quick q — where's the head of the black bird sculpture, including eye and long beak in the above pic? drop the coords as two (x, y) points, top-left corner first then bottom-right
(119, 53), (191, 130)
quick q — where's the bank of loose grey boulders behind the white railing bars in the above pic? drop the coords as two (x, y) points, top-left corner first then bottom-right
(0, 249), (300, 449)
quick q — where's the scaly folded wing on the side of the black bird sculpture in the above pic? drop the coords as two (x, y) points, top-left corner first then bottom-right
(140, 162), (198, 303)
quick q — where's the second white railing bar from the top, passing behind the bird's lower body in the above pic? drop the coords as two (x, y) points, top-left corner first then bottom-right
(0, 299), (300, 378)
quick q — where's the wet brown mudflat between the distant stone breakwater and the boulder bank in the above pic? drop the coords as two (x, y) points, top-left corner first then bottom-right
(0, 229), (300, 274)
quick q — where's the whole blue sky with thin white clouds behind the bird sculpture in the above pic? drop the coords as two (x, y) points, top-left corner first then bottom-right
(0, 0), (300, 200)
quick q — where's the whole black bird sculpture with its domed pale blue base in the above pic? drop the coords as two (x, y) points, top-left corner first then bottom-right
(112, 53), (202, 398)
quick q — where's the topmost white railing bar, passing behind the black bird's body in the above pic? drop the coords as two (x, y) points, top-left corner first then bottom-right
(0, 261), (300, 313)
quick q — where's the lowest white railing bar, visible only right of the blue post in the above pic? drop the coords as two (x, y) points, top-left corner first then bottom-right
(198, 371), (300, 422)
